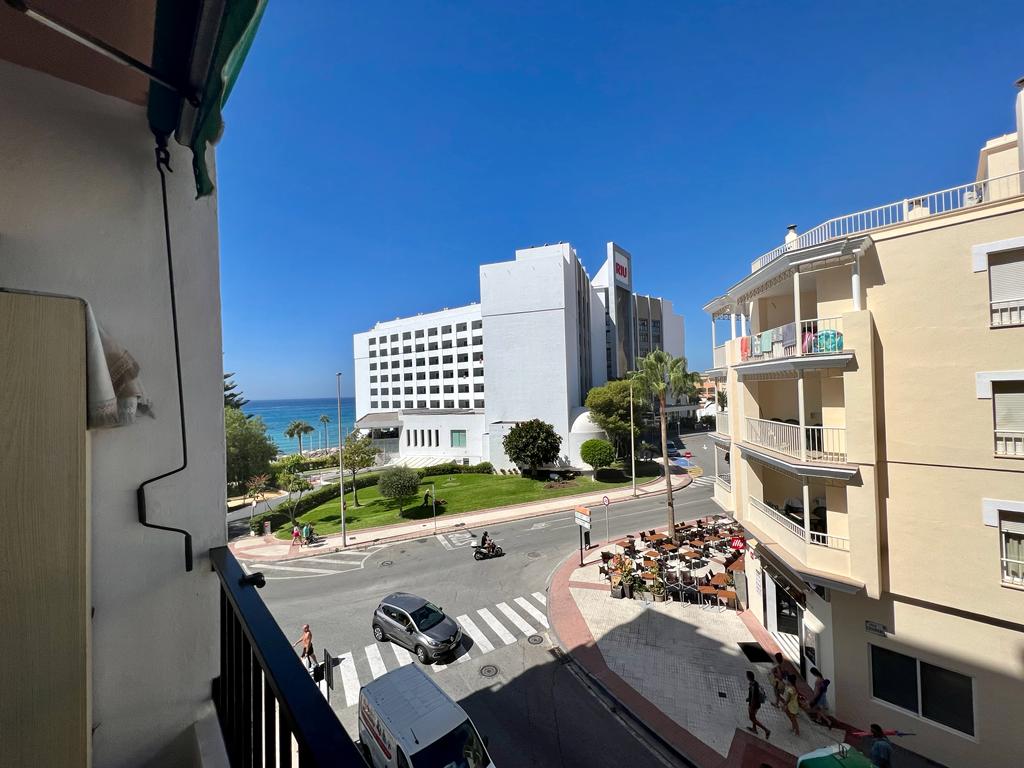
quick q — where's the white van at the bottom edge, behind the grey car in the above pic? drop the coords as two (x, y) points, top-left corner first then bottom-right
(359, 665), (494, 768)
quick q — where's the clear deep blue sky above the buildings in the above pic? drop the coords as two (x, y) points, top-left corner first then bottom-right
(217, 0), (1024, 398)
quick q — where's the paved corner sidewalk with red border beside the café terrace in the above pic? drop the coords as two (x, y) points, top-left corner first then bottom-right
(548, 549), (846, 768)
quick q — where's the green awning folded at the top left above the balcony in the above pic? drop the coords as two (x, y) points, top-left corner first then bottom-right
(147, 0), (266, 198)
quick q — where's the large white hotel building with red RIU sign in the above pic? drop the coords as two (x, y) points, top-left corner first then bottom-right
(352, 243), (684, 468)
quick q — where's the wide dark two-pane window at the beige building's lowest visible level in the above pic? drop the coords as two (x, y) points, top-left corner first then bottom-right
(870, 645), (974, 736)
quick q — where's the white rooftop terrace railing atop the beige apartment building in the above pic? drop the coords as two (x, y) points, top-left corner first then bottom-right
(751, 171), (1024, 272)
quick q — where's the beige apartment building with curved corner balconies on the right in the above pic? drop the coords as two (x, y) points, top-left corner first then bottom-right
(705, 79), (1024, 766)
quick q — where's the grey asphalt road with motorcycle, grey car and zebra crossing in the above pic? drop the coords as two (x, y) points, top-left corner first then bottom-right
(259, 435), (721, 768)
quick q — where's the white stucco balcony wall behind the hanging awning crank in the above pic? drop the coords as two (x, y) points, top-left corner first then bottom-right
(0, 61), (224, 768)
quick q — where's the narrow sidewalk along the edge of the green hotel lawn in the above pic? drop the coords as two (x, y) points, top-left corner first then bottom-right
(227, 466), (693, 561)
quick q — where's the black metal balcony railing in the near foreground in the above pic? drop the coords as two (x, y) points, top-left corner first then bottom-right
(210, 547), (366, 768)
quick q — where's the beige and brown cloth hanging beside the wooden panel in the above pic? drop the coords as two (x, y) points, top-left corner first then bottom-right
(85, 304), (154, 429)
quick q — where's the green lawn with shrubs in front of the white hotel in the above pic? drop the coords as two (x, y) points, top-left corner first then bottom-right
(276, 472), (641, 539)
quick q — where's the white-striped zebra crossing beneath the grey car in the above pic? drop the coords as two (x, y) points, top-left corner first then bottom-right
(335, 592), (548, 708)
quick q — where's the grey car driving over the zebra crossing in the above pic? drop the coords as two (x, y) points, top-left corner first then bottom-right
(373, 592), (462, 664)
